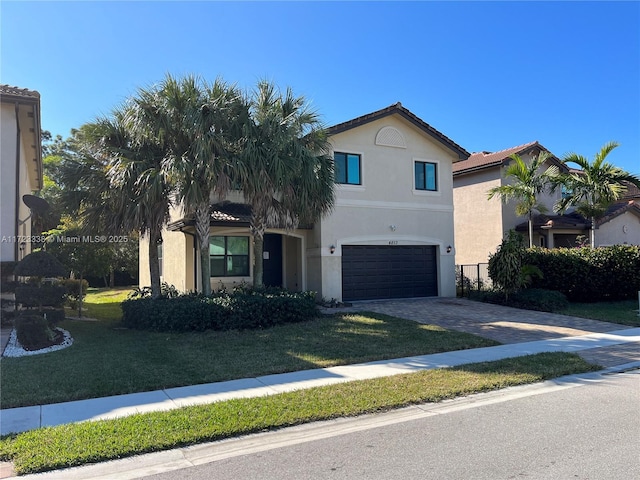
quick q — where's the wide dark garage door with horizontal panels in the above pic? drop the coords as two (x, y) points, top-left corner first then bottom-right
(342, 245), (438, 300)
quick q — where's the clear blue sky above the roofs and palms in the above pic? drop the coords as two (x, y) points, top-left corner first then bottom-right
(0, 0), (640, 174)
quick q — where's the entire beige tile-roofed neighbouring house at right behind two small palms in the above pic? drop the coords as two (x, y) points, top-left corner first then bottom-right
(453, 142), (640, 265)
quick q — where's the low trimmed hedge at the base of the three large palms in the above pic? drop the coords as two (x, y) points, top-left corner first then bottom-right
(122, 289), (318, 332)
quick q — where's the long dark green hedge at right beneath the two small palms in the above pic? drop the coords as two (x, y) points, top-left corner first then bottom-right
(523, 245), (640, 302)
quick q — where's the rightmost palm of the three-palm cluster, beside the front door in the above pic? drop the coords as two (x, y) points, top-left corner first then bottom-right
(233, 81), (334, 287)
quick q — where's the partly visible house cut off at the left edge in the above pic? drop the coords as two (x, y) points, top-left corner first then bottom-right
(0, 85), (42, 262)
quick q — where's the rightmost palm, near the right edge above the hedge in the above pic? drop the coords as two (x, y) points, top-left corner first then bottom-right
(556, 142), (640, 248)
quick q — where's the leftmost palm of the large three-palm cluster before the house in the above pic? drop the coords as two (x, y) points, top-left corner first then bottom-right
(60, 105), (172, 297)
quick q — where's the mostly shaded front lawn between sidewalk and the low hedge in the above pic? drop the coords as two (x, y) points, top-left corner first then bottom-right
(0, 291), (496, 408)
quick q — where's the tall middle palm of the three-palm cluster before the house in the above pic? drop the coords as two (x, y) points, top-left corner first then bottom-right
(133, 75), (242, 295)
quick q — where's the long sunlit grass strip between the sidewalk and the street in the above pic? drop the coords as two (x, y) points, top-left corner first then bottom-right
(0, 353), (599, 474)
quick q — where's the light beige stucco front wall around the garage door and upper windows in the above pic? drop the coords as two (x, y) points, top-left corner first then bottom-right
(318, 116), (457, 300)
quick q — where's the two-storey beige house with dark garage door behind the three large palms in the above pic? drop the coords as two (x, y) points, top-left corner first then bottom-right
(140, 103), (469, 301)
